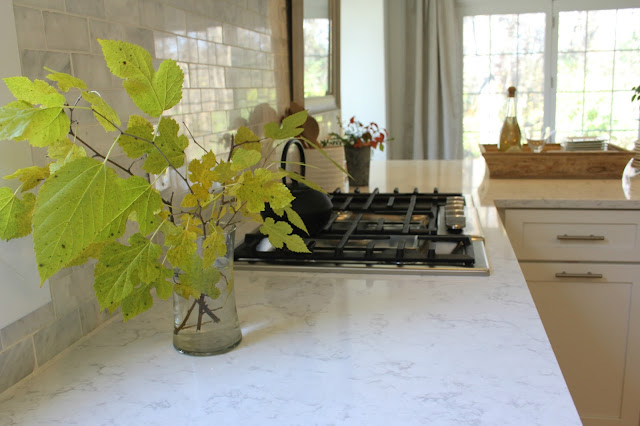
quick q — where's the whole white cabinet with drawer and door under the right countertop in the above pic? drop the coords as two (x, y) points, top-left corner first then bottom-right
(504, 209), (640, 426)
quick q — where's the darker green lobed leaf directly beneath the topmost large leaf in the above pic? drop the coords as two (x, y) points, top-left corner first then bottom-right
(142, 117), (189, 175)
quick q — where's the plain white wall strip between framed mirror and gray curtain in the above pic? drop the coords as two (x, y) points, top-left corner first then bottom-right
(340, 0), (393, 159)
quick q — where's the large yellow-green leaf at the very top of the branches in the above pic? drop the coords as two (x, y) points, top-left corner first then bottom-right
(98, 39), (184, 117)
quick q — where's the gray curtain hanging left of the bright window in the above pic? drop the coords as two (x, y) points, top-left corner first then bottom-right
(385, 0), (463, 160)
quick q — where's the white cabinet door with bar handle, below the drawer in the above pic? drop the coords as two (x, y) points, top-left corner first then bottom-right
(521, 262), (640, 426)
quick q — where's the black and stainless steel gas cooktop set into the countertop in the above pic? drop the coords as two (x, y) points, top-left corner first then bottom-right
(234, 189), (489, 275)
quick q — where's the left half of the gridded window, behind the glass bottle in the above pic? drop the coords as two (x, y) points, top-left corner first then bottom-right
(463, 13), (546, 153)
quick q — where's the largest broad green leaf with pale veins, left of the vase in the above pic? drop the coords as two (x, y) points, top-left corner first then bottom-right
(33, 158), (124, 282)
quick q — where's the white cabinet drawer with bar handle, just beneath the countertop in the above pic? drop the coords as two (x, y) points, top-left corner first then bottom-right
(505, 209), (640, 262)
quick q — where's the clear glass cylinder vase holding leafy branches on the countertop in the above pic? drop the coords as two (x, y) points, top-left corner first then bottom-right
(173, 228), (242, 356)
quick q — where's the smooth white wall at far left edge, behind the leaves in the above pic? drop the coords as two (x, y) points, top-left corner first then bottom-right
(0, 1), (51, 329)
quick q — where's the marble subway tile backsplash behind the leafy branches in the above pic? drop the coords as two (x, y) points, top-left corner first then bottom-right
(0, 0), (290, 392)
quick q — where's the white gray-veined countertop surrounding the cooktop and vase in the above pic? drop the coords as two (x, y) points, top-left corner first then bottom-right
(5, 159), (640, 426)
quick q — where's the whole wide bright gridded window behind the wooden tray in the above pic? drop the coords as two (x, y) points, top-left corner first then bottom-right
(459, 0), (640, 155)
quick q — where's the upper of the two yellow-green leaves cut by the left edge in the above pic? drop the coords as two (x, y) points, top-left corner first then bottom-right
(0, 101), (71, 146)
